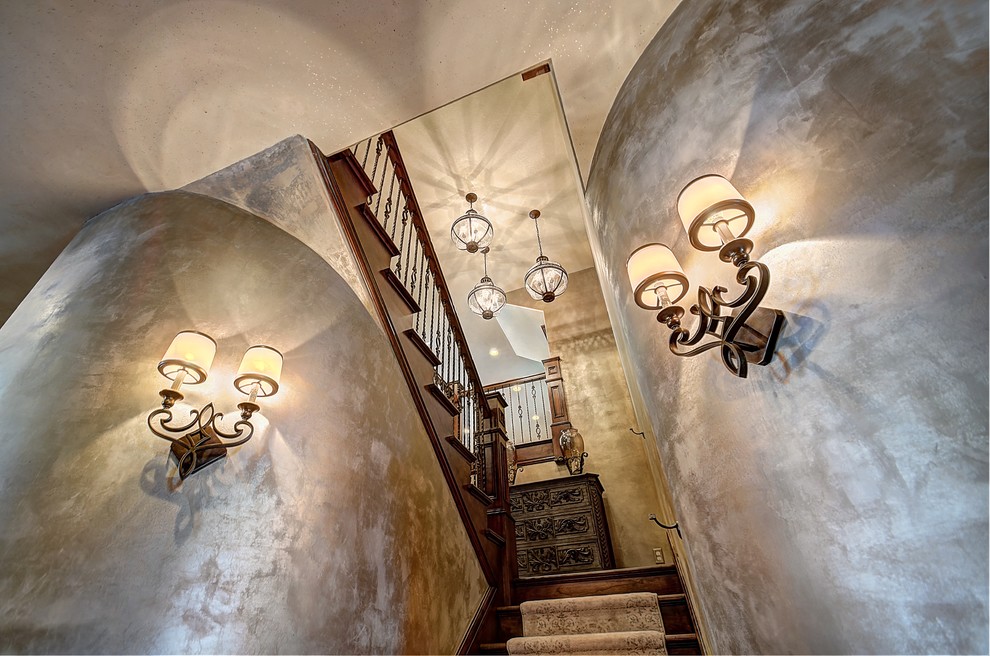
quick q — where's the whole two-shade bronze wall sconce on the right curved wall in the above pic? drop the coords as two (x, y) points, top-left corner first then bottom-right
(626, 175), (784, 378)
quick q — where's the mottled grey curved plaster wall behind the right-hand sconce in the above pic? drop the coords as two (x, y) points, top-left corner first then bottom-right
(588, 0), (988, 653)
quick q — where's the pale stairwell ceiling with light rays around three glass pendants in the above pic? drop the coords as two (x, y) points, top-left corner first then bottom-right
(395, 65), (594, 384)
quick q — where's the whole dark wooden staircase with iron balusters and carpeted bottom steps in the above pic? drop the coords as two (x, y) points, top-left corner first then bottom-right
(310, 132), (702, 654)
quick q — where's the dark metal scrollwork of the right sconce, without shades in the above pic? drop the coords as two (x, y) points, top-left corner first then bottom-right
(657, 260), (784, 378)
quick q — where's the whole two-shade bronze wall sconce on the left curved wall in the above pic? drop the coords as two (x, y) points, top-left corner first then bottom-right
(148, 330), (282, 479)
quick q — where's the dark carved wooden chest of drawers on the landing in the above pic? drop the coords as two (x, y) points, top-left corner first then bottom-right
(510, 474), (615, 577)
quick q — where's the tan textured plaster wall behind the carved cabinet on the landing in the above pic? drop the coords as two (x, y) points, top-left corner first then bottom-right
(508, 268), (673, 567)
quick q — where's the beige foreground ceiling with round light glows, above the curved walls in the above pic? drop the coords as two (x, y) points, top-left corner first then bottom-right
(0, 0), (677, 321)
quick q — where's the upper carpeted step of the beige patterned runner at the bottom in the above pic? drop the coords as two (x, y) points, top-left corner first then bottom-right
(519, 592), (664, 637)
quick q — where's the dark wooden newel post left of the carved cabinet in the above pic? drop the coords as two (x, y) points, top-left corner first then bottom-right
(485, 392), (519, 606)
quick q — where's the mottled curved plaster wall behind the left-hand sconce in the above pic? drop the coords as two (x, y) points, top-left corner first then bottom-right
(0, 192), (487, 653)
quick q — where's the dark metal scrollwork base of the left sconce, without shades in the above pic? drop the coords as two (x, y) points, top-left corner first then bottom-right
(148, 403), (254, 479)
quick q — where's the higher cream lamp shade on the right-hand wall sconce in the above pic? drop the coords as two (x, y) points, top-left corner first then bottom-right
(677, 174), (756, 251)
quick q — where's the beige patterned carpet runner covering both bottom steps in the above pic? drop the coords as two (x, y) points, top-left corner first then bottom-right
(506, 592), (667, 655)
